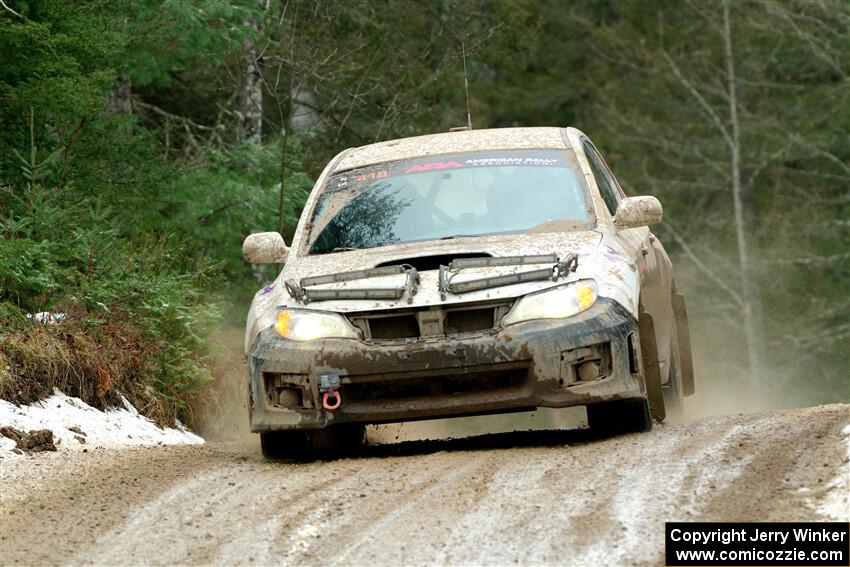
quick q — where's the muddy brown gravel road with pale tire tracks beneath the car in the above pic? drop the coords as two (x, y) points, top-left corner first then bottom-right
(0, 405), (850, 565)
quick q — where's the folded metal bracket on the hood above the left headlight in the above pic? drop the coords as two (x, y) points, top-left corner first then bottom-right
(285, 264), (419, 304)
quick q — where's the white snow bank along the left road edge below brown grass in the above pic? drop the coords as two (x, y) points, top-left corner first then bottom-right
(0, 390), (204, 457)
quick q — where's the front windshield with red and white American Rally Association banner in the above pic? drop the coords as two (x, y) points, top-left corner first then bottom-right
(308, 150), (591, 254)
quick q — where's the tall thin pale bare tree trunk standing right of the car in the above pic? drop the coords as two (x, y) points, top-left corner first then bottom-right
(723, 0), (759, 385)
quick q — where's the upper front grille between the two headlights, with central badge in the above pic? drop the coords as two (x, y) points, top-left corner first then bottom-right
(350, 303), (512, 341)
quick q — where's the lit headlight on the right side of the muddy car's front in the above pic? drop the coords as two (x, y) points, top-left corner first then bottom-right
(502, 280), (596, 326)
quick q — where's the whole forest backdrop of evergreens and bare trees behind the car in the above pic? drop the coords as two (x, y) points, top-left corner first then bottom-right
(0, 0), (850, 423)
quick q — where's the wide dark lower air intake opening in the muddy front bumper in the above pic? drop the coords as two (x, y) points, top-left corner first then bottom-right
(343, 367), (528, 402)
